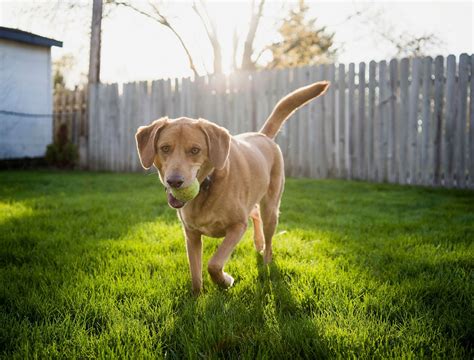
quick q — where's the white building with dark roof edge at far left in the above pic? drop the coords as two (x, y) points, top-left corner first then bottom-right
(0, 27), (62, 159)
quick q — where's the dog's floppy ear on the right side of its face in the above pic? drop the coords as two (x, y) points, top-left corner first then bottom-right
(199, 119), (230, 170)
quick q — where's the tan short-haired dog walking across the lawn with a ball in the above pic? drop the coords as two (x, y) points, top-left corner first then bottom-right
(135, 81), (329, 293)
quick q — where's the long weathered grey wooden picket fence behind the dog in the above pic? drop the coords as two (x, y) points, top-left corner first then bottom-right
(54, 54), (474, 188)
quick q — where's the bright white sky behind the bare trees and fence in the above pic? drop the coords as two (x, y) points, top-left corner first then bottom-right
(0, 0), (474, 86)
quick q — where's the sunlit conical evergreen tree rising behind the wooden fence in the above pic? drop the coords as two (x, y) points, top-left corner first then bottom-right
(267, 0), (336, 69)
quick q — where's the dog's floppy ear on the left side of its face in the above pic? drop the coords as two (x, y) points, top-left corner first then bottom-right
(135, 117), (168, 169)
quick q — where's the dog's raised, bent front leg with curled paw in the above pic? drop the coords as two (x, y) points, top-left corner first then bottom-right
(207, 223), (247, 288)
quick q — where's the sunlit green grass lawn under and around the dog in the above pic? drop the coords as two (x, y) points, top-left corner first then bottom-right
(0, 171), (474, 359)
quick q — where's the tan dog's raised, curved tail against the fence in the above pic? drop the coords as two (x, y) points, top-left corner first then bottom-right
(260, 81), (330, 139)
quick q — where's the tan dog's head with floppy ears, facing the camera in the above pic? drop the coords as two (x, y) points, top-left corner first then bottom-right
(135, 118), (230, 208)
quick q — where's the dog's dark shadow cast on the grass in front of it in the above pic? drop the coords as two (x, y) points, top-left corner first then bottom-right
(163, 255), (329, 359)
